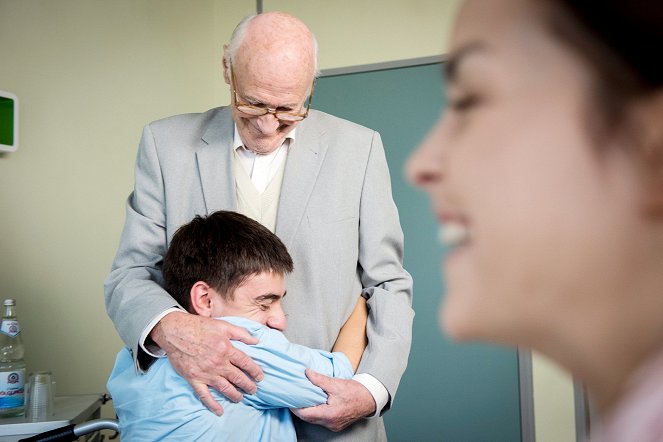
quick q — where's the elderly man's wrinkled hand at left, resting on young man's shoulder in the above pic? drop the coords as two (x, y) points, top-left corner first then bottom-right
(150, 312), (263, 415)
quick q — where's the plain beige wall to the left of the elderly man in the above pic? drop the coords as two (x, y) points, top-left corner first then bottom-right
(0, 0), (223, 422)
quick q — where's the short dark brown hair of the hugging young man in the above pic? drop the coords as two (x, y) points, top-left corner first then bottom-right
(162, 211), (293, 312)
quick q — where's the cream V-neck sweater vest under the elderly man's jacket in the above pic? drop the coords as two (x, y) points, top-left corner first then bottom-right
(233, 150), (286, 232)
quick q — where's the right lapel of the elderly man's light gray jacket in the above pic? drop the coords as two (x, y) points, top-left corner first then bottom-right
(276, 111), (327, 248)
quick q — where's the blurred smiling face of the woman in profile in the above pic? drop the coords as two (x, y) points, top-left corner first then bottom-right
(408, 0), (646, 345)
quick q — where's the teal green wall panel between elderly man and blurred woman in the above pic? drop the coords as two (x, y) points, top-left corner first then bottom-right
(312, 63), (521, 442)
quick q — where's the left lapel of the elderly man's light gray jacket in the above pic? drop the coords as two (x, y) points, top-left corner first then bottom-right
(196, 107), (237, 213)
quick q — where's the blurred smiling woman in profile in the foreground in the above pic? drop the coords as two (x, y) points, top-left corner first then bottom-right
(408, 0), (663, 442)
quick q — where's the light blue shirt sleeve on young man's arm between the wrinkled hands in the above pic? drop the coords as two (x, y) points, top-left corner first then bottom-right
(232, 327), (353, 409)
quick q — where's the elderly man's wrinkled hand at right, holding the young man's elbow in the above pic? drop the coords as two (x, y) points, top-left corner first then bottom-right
(291, 369), (375, 431)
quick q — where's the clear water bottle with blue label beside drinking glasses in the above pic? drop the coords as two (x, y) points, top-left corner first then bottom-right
(0, 299), (25, 417)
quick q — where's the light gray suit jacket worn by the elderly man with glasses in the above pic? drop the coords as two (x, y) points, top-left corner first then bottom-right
(105, 108), (414, 441)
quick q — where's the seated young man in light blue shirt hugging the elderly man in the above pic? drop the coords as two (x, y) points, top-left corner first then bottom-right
(108, 211), (367, 441)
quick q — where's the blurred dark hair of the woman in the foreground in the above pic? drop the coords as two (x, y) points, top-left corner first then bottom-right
(546, 0), (663, 131)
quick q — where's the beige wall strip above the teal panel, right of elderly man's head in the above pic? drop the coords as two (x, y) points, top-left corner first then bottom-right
(263, 0), (459, 69)
